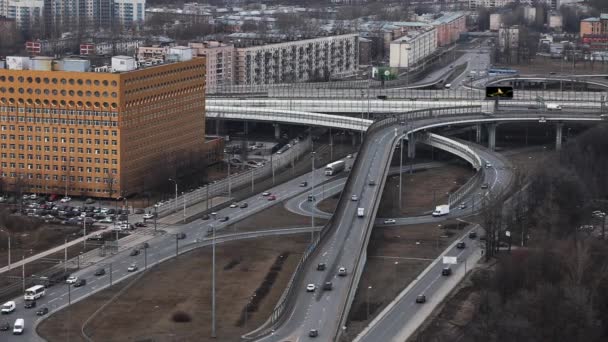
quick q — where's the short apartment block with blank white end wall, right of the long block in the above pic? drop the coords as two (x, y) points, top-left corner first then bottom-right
(389, 27), (437, 68)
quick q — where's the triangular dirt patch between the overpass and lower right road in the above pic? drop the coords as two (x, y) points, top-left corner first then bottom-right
(345, 221), (464, 341)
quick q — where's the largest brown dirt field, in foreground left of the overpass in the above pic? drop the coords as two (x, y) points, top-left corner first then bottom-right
(38, 234), (308, 342)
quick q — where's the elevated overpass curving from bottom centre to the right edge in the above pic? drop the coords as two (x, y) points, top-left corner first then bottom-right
(245, 107), (602, 341)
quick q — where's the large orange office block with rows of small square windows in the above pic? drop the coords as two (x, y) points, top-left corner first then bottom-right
(0, 58), (221, 197)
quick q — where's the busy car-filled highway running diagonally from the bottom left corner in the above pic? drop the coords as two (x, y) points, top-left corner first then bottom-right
(0, 159), (354, 342)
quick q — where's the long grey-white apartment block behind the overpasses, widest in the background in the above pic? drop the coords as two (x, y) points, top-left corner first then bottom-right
(235, 34), (359, 85)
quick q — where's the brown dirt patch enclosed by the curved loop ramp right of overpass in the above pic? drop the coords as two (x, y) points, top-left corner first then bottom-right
(378, 165), (474, 217)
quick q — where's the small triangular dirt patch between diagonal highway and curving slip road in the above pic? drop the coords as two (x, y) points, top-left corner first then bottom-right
(224, 199), (327, 233)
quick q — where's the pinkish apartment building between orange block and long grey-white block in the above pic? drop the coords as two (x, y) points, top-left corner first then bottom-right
(188, 41), (235, 92)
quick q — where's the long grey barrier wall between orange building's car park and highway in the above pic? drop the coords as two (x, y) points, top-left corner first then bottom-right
(156, 136), (311, 217)
